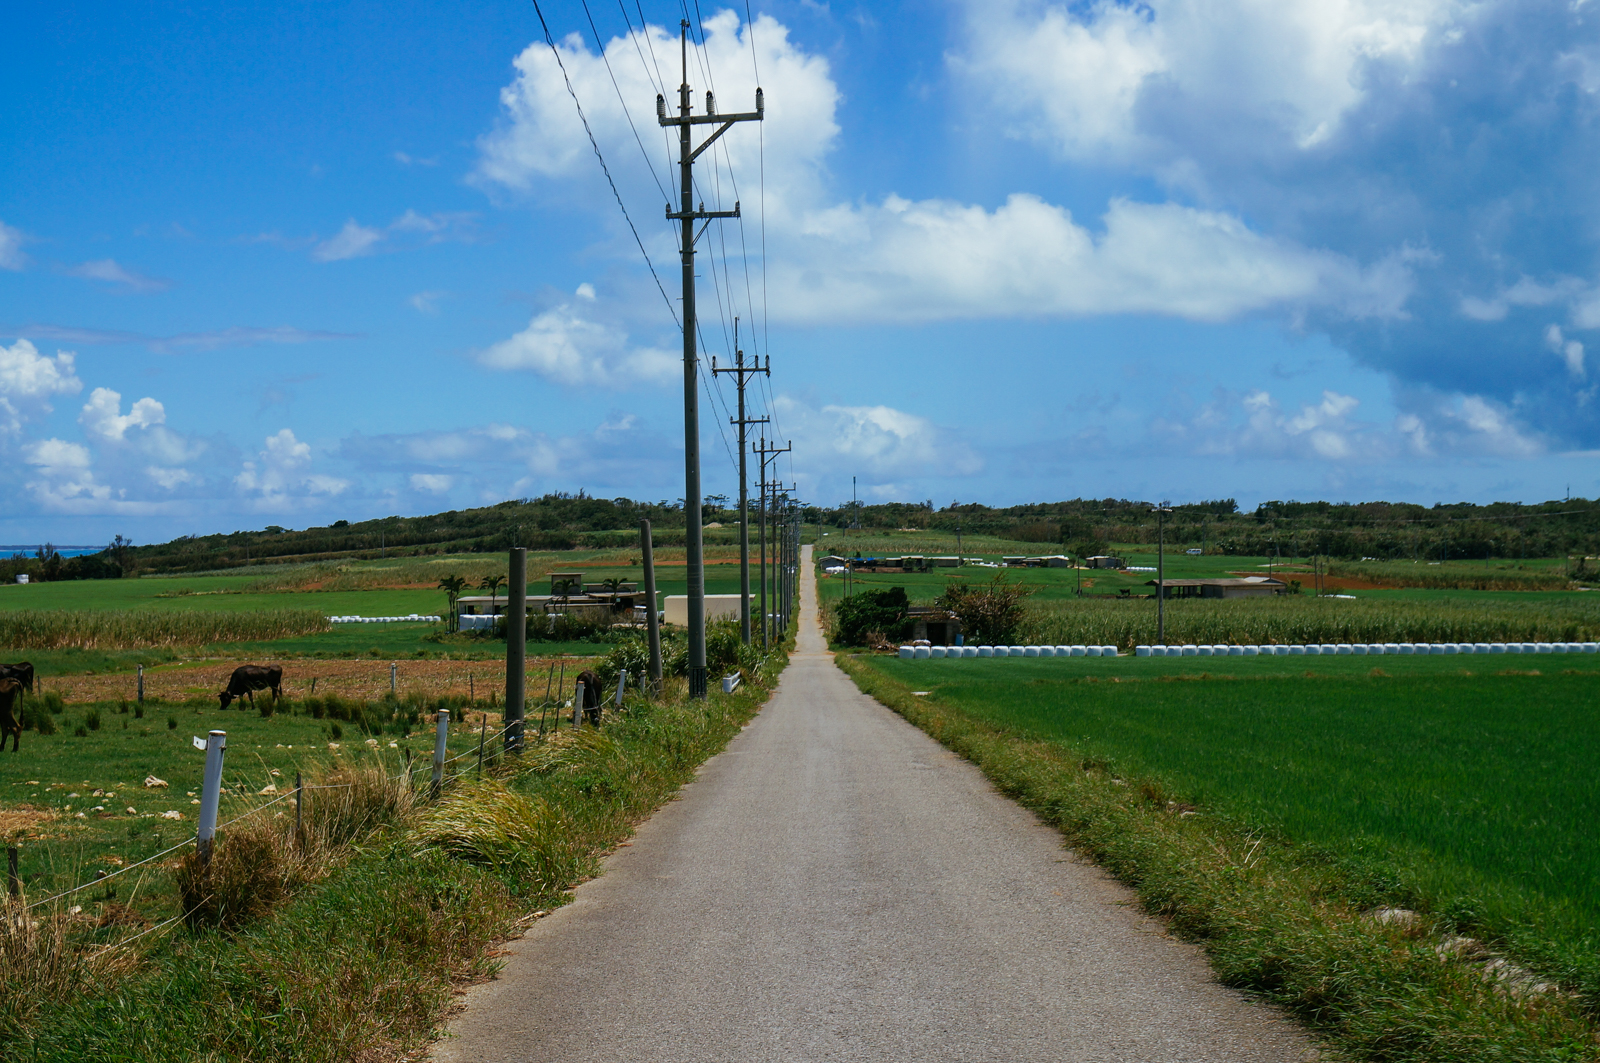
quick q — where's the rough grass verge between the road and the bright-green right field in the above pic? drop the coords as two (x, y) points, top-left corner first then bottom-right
(838, 655), (1600, 1063)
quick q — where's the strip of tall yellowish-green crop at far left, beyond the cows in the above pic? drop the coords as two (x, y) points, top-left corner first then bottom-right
(0, 608), (331, 650)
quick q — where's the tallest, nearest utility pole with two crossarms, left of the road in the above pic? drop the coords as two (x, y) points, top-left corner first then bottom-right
(656, 19), (766, 698)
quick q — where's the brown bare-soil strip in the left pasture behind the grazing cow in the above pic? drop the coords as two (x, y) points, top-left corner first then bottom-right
(48, 656), (587, 701)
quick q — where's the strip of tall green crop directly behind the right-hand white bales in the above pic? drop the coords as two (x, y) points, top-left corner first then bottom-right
(1021, 596), (1600, 650)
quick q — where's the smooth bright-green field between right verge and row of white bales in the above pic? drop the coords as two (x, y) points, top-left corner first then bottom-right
(859, 655), (1600, 1002)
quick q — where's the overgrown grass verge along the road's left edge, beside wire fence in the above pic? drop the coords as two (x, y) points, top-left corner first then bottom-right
(0, 633), (786, 1063)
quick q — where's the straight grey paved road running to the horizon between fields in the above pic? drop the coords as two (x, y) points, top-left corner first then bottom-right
(434, 548), (1315, 1063)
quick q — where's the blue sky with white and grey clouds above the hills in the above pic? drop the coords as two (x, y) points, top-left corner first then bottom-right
(0, 0), (1600, 543)
